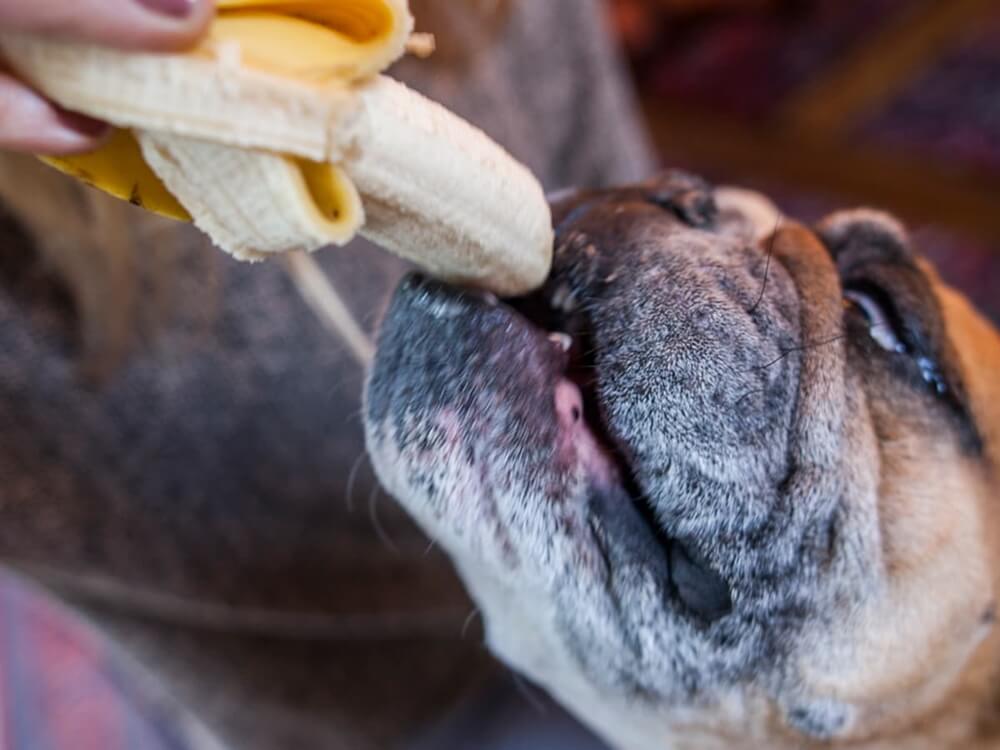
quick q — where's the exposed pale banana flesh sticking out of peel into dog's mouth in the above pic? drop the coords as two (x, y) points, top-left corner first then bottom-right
(344, 77), (552, 295)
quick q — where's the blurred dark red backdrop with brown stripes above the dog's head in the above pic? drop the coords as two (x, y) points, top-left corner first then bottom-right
(608, 0), (1000, 320)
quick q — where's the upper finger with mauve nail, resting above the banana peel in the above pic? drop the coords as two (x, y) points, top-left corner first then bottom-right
(0, 0), (215, 51)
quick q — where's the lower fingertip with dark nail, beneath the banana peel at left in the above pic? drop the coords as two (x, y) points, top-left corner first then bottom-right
(0, 72), (108, 155)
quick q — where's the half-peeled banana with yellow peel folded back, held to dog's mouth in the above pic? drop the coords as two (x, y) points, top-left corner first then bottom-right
(0, 0), (552, 294)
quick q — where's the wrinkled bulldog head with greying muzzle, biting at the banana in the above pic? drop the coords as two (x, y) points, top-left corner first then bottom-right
(366, 173), (1000, 750)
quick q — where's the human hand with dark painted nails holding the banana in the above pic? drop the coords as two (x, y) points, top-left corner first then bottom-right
(0, 0), (214, 155)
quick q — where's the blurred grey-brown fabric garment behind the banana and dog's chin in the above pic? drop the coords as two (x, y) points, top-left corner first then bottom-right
(0, 0), (651, 748)
